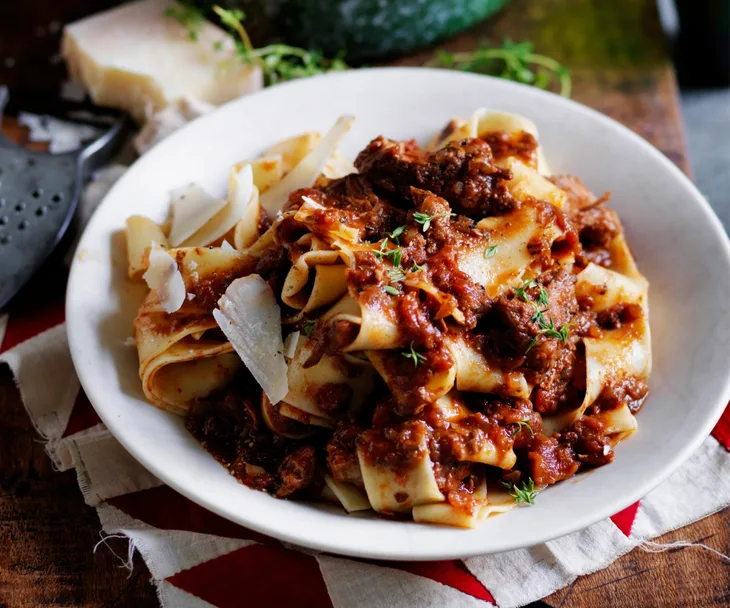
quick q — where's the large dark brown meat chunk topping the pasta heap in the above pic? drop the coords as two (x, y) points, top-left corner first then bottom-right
(355, 136), (517, 218)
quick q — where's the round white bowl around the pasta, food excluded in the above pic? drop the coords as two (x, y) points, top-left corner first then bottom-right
(66, 68), (730, 560)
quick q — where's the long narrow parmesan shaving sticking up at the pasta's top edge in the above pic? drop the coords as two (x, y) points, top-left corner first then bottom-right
(260, 116), (355, 216)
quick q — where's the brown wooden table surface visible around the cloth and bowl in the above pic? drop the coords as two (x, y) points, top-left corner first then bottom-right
(0, 0), (730, 608)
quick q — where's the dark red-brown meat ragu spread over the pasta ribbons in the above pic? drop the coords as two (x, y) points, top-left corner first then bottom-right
(187, 133), (647, 509)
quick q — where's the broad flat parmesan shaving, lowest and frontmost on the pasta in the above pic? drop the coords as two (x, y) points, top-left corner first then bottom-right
(213, 274), (289, 404)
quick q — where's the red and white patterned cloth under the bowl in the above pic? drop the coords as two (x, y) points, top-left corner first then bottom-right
(0, 274), (730, 608)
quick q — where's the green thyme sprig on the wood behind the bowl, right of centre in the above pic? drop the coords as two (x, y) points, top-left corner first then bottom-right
(426, 38), (572, 97)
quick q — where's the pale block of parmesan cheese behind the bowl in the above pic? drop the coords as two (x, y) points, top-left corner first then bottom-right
(61, 0), (263, 122)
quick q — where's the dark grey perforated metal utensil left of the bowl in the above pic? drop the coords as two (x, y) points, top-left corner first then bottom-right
(0, 87), (127, 310)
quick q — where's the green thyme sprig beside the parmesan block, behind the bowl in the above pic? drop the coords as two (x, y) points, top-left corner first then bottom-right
(213, 5), (348, 86)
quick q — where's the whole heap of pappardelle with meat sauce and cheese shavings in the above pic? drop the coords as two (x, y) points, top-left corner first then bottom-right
(127, 110), (651, 527)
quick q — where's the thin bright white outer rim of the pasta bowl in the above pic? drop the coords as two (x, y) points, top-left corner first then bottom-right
(65, 66), (730, 561)
